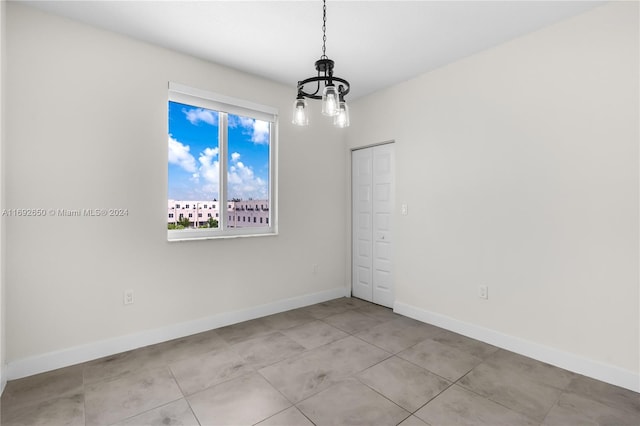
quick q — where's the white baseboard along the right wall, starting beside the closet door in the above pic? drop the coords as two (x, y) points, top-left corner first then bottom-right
(393, 302), (640, 392)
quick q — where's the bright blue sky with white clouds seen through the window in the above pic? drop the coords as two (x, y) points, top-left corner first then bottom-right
(168, 102), (269, 200)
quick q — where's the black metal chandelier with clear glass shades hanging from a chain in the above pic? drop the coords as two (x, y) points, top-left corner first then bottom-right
(293, 0), (351, 127)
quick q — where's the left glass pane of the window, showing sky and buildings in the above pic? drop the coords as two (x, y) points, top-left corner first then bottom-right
(168, 101), (220, 229)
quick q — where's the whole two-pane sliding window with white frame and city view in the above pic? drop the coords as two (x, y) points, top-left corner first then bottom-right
(167, 83), (277, 240)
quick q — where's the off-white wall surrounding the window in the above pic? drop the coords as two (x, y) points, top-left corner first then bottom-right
(5, 3), (347, 376)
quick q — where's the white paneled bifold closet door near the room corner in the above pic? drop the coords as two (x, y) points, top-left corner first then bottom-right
(352, 144), (395, 307)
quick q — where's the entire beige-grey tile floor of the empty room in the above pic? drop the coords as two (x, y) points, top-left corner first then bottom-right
(1, 298), (640, 426)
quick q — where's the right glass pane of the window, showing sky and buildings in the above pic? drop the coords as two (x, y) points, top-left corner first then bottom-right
(226, 114), (271, 228)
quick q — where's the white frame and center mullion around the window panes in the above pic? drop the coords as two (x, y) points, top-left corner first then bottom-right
(169, 82), (278, 241)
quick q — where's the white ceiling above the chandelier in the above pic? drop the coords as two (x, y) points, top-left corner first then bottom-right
(22, 0), (603, 99)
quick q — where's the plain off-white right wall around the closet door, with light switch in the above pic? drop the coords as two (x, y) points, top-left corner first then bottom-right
(348, 2), (640, 390)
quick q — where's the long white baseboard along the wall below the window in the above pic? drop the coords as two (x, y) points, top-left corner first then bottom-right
(3, 287), (350, 380)
